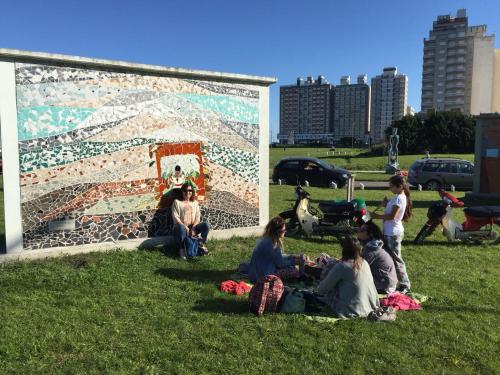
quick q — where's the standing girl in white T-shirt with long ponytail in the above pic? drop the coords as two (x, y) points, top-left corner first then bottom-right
(371, 175), (413, 293)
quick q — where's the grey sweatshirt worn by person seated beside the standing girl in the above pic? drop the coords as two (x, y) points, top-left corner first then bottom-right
(363, 240), (398, 293)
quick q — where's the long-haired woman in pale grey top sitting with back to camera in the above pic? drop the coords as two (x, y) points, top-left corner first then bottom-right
(317, 238), (378, 318)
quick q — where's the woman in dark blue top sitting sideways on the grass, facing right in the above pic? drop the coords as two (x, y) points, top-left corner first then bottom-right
(248, 216), (306, 283)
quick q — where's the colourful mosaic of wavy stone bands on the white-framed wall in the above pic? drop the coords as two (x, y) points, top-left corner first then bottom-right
(16, 64), (259, 249)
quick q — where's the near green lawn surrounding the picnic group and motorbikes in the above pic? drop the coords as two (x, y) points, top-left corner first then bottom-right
(0, 186), (500, 374)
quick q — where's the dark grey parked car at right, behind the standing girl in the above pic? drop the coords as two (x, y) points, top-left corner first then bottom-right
(408, 158), (474, 190)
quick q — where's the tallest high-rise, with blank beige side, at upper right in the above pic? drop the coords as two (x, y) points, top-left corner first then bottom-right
(422, 9), (495, 115)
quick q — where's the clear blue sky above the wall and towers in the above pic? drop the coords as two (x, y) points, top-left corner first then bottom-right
(0, 0), (500, 139)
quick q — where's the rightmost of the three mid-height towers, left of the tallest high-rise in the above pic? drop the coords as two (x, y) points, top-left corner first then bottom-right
(370, 67), (408, 143)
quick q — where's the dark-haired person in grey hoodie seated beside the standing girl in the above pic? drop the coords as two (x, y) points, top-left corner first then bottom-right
(358, 221), (398, 294)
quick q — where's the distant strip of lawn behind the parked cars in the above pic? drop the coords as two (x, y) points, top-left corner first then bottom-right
(269, 147), (474, 177)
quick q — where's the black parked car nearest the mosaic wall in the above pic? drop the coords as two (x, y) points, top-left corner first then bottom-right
(272, 157), (351, 188)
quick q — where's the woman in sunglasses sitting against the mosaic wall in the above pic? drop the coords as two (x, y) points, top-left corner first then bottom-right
(172, 182), (210, 258)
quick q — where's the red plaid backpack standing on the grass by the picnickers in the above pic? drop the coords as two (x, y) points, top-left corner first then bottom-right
(248, 275), (284, 316)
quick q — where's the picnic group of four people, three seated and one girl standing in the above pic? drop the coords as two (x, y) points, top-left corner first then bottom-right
(246, 176), (412, 318)
